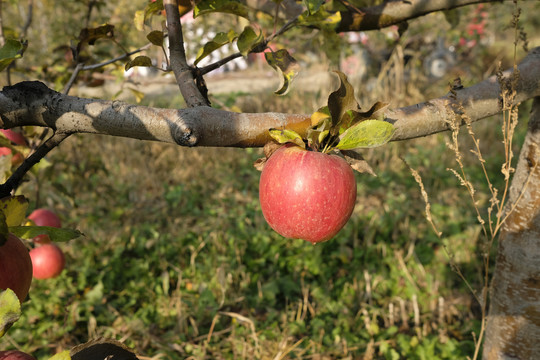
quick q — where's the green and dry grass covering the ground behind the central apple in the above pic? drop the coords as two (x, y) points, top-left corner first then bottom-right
(0, 2), (527, 360)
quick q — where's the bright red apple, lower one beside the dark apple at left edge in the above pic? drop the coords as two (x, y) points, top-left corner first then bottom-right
(30, 243), (66, 279)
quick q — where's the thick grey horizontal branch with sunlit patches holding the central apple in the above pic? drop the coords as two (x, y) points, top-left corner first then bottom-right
(0, 47), (540, 147)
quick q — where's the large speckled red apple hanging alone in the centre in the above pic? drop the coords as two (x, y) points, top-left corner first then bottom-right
(259, 144), (356, 244)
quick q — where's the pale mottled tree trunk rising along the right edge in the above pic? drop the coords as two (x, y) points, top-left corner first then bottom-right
(483, 97), (540, 360)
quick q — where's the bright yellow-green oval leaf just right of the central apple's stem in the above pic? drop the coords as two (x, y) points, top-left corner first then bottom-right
(336, 120), (395, 150)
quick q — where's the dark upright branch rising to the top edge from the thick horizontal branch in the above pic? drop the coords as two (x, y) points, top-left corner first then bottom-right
(163, 0), (210, 107)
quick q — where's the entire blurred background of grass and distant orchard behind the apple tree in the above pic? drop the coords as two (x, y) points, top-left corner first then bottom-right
(0, 0), (540, 359)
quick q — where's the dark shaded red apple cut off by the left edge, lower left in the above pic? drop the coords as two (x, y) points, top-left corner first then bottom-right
(0, 234), (32, 302)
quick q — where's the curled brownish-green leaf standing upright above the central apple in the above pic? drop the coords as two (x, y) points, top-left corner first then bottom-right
(328, 71), (359, 135)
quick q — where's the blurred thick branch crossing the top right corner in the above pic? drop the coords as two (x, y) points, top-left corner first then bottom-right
(336, 0), (510, 32)
